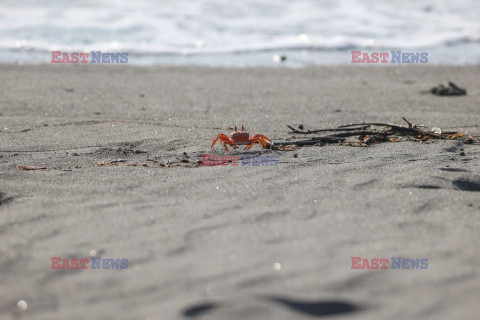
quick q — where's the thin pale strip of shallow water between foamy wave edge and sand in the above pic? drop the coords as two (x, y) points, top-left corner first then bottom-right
(0, 43), (480, 68)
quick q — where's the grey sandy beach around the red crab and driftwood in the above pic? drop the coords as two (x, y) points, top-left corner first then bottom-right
(0, 65), (480, 320)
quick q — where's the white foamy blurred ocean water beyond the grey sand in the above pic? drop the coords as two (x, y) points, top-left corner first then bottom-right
(0, 0), (480, 67)
